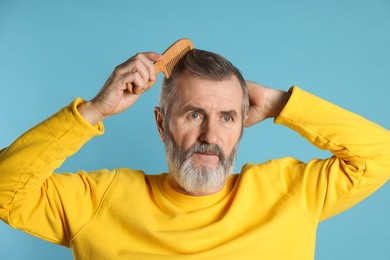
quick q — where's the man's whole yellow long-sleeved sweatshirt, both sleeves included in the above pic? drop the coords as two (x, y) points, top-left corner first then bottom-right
(0, 87), (390, 260)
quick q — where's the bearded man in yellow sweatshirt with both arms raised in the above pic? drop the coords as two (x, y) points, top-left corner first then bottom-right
(0, 50), (390, 260)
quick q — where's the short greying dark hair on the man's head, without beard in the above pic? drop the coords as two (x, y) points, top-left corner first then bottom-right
(159, 49), (249, 123)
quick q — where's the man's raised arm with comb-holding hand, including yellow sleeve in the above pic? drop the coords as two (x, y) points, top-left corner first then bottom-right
(0, 53), (160, 246)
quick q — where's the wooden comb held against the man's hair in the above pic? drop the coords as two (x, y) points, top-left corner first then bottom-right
(126, 38), (194, 94)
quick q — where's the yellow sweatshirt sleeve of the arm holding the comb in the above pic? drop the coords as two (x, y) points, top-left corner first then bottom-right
(0, 99), (113, 246)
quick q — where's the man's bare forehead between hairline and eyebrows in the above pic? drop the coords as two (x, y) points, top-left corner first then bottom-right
(174, 73), (243, 112)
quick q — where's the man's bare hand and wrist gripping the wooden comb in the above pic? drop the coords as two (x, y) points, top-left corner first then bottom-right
(78, 52), (162, 125)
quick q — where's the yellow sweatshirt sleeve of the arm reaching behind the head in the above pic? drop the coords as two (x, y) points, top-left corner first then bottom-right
(271, 87), (390, 221)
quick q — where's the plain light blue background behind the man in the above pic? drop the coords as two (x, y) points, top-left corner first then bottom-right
(0, 0), (390, 260)
